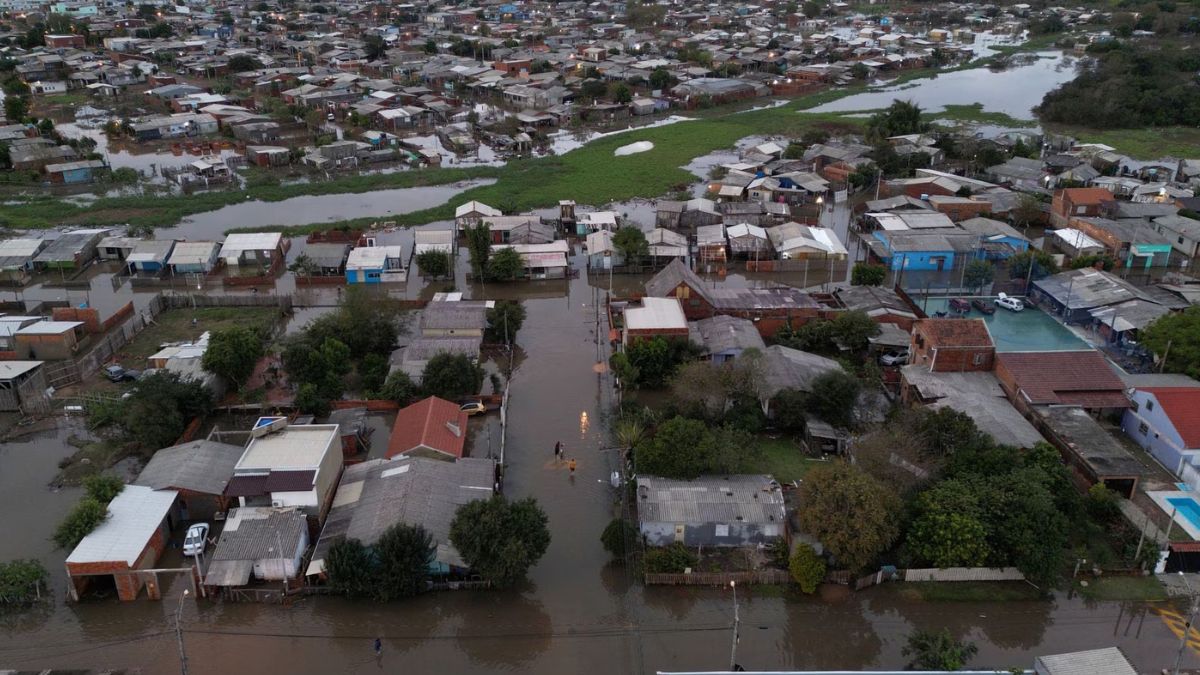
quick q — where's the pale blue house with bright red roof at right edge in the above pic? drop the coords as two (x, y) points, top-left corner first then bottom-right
(1121, 386), (1200, 476)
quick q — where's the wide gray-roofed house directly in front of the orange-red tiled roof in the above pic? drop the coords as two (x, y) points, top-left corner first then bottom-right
(305, 455), (496, 577)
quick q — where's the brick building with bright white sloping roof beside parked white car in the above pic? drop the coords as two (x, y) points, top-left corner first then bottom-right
(66, 485), (178, 602)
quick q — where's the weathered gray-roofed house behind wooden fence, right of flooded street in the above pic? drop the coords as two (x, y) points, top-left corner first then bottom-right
(637, 476), (787, 546)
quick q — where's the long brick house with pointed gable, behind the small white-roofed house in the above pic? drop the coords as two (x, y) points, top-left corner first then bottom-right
(646, 258), (827, 338)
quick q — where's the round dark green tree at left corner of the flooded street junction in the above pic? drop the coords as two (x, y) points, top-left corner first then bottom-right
(450, 495), (550, 587)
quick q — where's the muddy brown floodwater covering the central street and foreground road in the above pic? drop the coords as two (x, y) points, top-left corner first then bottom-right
(0, 251), (1200, 675)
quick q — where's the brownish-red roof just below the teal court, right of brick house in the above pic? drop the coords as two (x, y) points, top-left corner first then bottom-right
(996, 351), (1129, 408)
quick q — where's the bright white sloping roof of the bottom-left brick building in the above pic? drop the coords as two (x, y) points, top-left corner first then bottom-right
(67, 485), (179, 566)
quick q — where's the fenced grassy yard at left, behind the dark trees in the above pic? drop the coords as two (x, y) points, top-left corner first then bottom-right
(118, 307), (280, 370)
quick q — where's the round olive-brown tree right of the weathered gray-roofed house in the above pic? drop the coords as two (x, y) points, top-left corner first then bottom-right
(798, 461), (900, 572)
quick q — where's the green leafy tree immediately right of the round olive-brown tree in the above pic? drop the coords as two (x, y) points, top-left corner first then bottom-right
(905, 480), (990, 567)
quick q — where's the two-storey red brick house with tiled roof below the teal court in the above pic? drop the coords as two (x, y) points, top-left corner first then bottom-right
(908, 318), (996, 372)
